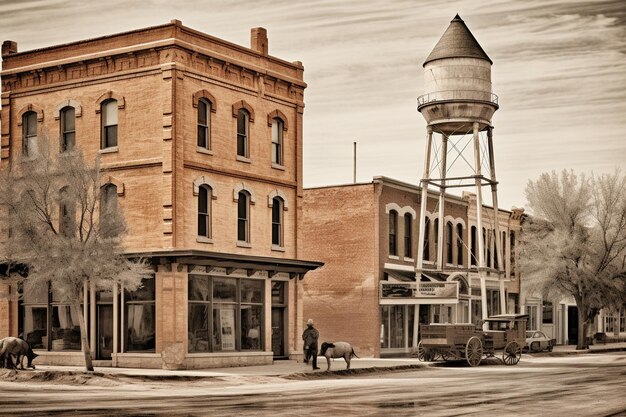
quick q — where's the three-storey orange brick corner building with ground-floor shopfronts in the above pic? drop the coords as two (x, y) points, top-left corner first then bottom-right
(0, 20), (321, 368)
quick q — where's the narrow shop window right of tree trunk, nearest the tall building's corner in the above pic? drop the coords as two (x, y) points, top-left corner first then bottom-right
(124, 277), (156, 352)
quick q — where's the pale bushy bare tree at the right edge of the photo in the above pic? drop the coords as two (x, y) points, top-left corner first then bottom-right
(521, 170), (626, 349)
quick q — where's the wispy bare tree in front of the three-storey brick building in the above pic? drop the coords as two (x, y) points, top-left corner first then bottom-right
(0, 135), (151, 371)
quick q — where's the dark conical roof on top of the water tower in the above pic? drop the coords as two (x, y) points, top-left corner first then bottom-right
(424, 14), (493, 65)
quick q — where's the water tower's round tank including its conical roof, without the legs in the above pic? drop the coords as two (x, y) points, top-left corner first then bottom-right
(417, 14), (498, 134)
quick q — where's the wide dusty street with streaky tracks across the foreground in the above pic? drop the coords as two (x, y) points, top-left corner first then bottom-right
(0, 352), (626, 417)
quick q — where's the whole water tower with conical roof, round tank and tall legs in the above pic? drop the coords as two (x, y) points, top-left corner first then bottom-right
(416, 15), (506, 324)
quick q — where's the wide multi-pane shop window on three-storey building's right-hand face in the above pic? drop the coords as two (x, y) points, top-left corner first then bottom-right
(188, 275), (265, 352)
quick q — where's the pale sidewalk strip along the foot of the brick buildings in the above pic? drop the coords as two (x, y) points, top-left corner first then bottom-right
(26, 343), (626, 379)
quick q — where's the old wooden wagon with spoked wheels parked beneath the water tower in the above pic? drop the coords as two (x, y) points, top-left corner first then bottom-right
(417, 314), (528, 366)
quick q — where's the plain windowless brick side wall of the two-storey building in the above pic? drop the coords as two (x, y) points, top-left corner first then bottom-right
(300, 184), (380, 357)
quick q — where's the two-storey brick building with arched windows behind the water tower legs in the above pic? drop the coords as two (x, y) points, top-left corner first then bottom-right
(303, 177), (522, 357)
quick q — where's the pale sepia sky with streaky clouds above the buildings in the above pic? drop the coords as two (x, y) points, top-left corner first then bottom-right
(0, 0), (626, 209)
